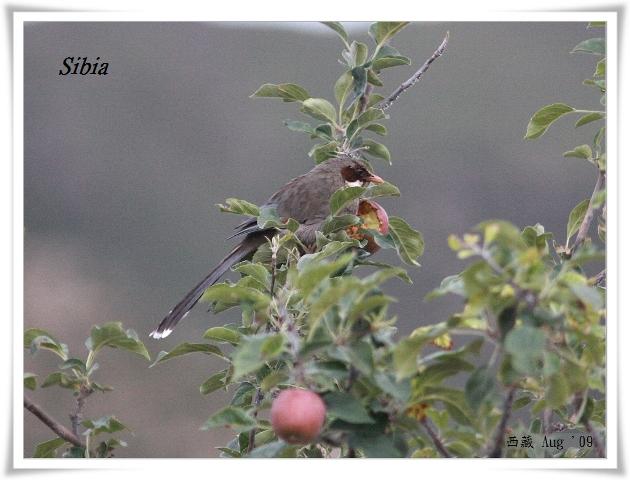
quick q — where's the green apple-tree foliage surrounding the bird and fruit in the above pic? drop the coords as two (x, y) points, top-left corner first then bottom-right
(24, 22), (606, 458)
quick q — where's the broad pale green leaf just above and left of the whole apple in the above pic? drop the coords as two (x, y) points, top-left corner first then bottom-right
(232, 333), (286, 380)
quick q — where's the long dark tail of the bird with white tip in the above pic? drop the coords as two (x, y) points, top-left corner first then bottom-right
(149, 232), (266, 339)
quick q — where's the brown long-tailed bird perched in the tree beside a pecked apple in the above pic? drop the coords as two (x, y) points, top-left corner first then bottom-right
(150, 156), (383, 339)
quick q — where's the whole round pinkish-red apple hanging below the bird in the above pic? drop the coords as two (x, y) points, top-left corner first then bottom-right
(271, 388), (326, 445)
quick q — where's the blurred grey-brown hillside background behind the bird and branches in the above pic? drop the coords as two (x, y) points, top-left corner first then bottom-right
(24, 22), (598, 457)
